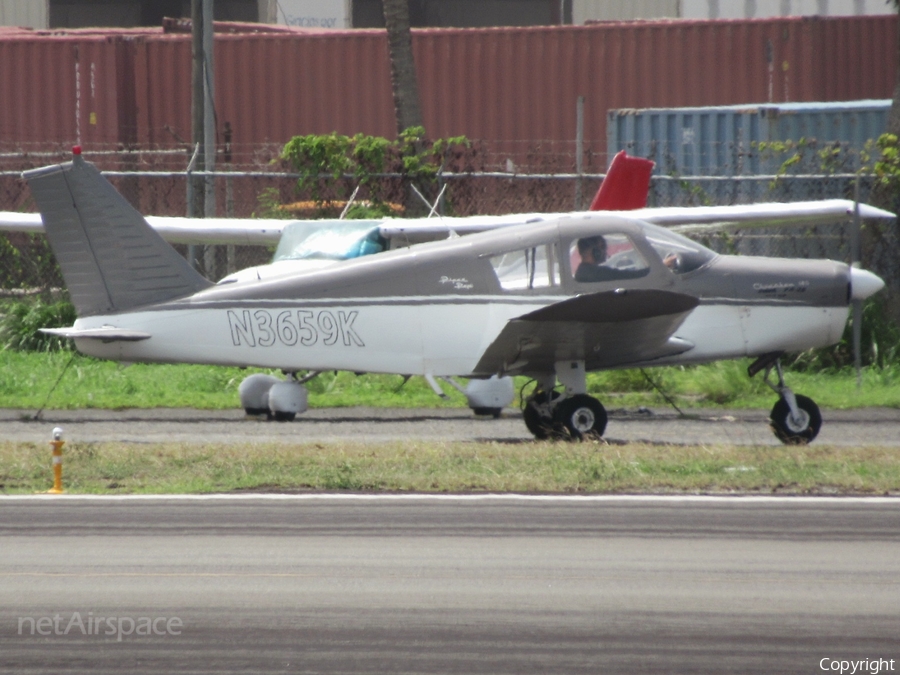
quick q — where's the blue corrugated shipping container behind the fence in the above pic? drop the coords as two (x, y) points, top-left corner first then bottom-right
(607, 100), (891, 176)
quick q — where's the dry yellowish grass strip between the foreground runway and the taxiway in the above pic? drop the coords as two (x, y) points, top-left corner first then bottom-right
(0, 441), (900, 494)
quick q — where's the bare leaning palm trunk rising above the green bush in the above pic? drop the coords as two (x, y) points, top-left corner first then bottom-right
(383, 0), (422, 134)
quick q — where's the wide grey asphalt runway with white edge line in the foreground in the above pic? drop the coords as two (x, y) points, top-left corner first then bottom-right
(0, 495), (900, 675)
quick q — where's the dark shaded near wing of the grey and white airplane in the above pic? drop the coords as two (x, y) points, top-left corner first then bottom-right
(476, 289), (699, 376)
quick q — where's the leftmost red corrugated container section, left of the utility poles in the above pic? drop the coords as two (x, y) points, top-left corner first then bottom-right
(0, 33), (130, 149)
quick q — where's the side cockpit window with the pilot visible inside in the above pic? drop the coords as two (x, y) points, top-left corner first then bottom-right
(569, 233), (650, 283)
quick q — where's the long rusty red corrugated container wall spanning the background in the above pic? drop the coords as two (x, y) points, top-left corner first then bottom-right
(0, 15), (898, 169)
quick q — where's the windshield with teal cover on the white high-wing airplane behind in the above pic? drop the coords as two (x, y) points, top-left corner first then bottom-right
(272, 220), (387, 262)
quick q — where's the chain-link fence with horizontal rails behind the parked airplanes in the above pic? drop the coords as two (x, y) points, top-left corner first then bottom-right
(0, 148), (900, 310)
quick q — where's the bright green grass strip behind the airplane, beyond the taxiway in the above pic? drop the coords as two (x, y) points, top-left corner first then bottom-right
(0, 350), (900, 409)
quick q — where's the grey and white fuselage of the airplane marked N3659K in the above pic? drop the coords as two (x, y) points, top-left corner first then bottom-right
(68, 215), (850, 377)
